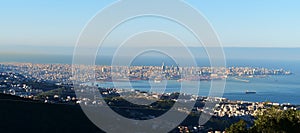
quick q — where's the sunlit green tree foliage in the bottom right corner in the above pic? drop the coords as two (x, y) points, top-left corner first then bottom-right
(226, 108), (300, 133)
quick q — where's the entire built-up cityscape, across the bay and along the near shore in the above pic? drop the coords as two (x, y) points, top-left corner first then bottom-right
(0, 63), (299, 132)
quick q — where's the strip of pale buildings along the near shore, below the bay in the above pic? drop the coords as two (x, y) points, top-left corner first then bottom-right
(72, 85), (297, 115)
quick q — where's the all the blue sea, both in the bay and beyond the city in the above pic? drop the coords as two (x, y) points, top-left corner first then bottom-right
(0, 49), (300, 105)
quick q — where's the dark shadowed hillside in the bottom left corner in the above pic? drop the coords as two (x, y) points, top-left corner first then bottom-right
(0, 94), (102, 133)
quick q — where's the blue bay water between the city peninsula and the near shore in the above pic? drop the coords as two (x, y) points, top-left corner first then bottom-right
(99, 75), (300, 105)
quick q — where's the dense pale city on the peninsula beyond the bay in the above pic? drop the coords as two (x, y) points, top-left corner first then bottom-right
(0, 63), (291, 84)
